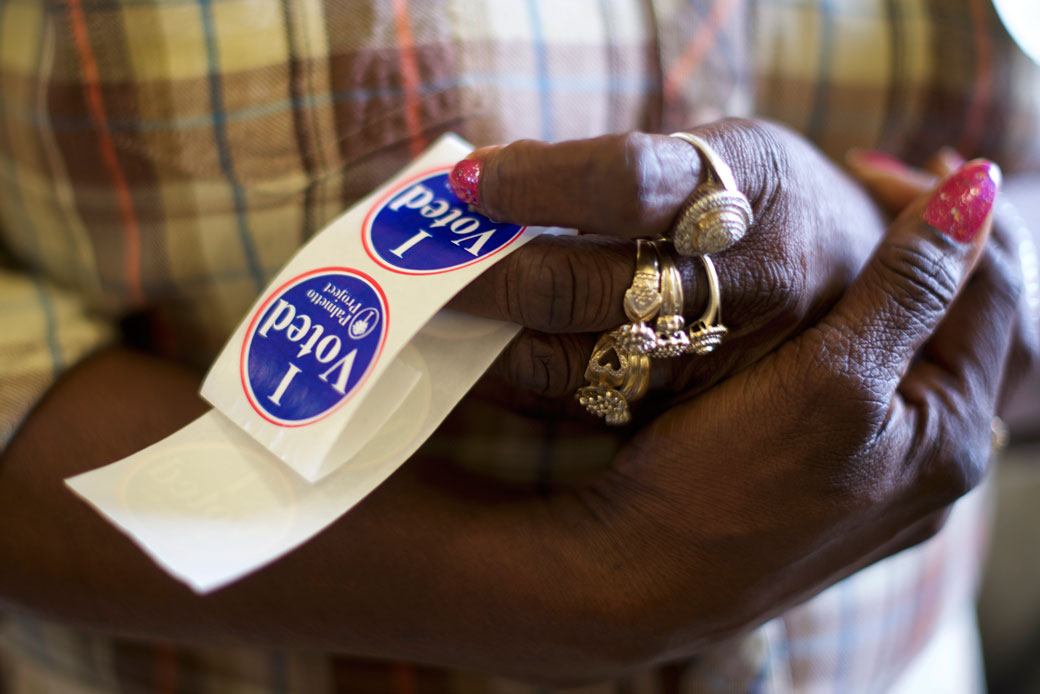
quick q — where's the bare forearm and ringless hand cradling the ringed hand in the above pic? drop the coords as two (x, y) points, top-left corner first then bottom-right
(0, 160), (1017, 683)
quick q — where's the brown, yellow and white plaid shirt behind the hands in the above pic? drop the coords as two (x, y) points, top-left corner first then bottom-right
(0, 0), (1040, 694)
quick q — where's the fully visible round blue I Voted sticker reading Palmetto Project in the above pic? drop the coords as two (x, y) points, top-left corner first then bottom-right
(240, 267), (388, 427)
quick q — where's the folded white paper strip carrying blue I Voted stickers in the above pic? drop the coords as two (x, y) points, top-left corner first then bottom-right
(67, 136), (561, 592)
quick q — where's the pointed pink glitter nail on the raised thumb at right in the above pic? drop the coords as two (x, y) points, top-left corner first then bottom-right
(924, 159), (1002, 243)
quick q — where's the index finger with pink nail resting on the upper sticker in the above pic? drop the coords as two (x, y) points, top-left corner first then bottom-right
(449, 119), (782, 243)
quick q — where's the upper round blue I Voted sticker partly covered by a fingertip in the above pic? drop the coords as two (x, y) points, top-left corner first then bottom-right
(362, 166), (524, 275)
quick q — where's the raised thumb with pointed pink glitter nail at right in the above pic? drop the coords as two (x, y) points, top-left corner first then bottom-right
(820, 159), (1000, 388)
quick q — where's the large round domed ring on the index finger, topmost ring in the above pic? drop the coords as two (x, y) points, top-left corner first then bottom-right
(670, 132), (754, 256)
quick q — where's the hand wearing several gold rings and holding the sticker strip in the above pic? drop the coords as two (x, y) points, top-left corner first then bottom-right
(452, 120), (884, 412)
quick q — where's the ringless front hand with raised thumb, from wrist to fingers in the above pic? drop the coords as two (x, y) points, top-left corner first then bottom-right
(540, 156), (1018, 660)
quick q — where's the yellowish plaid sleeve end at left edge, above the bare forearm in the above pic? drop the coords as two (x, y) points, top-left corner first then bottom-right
(0, 266), (116, 453)
